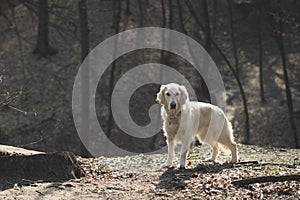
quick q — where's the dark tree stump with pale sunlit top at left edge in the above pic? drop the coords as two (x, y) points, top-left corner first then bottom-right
(0, 145), (84, 181)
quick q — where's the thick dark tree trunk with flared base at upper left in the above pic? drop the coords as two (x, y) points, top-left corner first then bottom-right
(33, 0), (56, 57)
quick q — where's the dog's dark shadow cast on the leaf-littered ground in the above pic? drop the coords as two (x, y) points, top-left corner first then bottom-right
(156, 163), (233, 191)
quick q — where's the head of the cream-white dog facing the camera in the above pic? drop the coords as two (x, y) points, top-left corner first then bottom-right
(156, 83), (189, 111)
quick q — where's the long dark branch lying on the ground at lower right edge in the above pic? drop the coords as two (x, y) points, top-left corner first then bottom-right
(231, 174), (300, 186)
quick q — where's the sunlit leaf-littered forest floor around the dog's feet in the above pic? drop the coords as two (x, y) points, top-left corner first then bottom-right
(0, 145), (300, 199)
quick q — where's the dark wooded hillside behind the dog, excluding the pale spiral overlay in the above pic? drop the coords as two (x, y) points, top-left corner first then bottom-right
(0, 0), (300, 155)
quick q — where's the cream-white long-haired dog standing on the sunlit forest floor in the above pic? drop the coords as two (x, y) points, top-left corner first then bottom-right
(156, 83), (237, 168)
